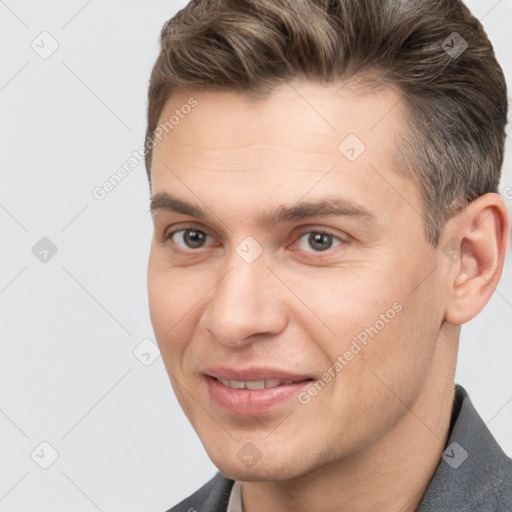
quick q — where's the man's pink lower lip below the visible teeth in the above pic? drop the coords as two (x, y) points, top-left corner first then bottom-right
(206, 375), (312, 415)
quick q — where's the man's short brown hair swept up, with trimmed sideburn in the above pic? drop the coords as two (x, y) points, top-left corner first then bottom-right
(145, 0), (507, 246)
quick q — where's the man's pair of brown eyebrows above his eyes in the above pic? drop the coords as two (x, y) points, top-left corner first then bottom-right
(149, 192), (377, 226)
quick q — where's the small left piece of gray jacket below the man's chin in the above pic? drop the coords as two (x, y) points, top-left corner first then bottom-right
(167, 472), (235, 512)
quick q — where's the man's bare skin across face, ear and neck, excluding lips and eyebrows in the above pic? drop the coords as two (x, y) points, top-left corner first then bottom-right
(148, 80), (509, 512)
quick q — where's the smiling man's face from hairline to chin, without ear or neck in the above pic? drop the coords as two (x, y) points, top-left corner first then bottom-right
(148, 81), (446, 480)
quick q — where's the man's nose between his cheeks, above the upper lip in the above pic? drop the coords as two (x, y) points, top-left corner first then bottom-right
(200, 249), (288, 347)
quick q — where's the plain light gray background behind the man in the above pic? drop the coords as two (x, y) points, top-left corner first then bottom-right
(0, 0), (512, 512)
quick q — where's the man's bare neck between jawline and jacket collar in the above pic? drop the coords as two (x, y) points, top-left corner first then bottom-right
(242, 328), (456, 512)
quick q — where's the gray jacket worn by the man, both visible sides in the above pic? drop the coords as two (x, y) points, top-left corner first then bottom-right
(167, 385), (512, 512)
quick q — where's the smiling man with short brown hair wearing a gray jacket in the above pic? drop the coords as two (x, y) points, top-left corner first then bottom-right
(146, 0), (512, 512)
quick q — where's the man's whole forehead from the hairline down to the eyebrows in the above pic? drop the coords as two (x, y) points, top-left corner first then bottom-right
(152, 80), (419, 228)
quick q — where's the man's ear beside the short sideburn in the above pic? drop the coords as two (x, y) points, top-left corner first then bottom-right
(439, 193), (510, 325)
